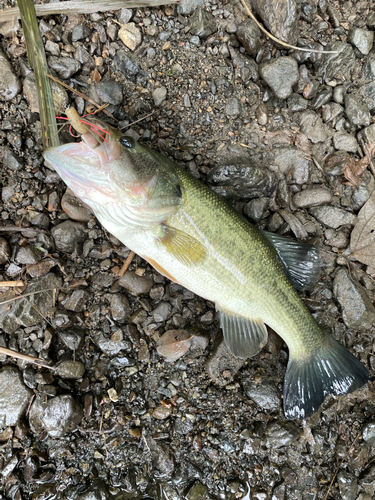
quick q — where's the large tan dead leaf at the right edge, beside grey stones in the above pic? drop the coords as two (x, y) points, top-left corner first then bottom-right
(350, 191), (375, 268)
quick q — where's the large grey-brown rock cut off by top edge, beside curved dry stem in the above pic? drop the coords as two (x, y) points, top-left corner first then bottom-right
(251, 0), (301, 44)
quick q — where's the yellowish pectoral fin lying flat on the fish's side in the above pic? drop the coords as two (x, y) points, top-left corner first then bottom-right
(158, 224), (208, 266)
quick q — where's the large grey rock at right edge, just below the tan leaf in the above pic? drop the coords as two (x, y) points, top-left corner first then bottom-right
(333, 268), (375, 331)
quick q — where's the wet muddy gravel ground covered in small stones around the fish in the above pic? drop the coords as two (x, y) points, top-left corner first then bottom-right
(0, 0), (375, 500)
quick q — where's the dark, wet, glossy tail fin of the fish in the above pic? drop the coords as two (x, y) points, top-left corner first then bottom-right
(284, 333), (369, 420)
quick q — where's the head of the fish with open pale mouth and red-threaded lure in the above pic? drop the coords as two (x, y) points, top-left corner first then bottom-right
(44, 119), (181, 228)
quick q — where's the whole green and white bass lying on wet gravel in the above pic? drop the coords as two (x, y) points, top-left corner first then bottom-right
(44, 119), (369, 420)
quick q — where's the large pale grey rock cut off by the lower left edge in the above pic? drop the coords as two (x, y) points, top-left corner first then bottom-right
(0, 366), (33, 428)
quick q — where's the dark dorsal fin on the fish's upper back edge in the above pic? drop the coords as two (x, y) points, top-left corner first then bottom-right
(262, 231), (322, 290)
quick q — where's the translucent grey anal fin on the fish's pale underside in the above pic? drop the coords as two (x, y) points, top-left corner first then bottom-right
(217, 307), (268, 359)
